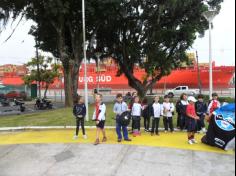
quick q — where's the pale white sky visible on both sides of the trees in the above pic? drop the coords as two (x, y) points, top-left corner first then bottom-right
(0, 0), (235, 66)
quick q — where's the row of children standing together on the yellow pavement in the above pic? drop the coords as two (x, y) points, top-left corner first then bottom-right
(73, 91), (220, 145)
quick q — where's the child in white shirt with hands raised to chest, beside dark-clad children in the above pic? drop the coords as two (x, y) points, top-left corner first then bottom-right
(163, 95), (175, 133)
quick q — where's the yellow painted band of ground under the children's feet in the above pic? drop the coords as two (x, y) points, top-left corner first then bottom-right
(0, 129), (233, 154)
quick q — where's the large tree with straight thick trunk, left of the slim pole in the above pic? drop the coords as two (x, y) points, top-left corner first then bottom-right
(0, 0), (96, 106)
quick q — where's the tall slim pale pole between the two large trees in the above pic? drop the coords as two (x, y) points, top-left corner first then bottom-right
(82, 0), (89, 121)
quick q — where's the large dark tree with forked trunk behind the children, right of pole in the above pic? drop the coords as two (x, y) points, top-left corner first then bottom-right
(94, 0), (222, 97)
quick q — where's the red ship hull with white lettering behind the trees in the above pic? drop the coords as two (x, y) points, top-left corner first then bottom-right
(0, 64), (235, 89)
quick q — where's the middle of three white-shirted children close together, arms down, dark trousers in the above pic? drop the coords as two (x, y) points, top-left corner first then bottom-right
(151, 96), (162, 136)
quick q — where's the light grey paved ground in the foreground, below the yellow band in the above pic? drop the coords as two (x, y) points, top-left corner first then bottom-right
(0, 144), (235, 176)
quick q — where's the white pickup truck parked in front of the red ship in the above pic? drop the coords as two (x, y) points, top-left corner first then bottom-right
(165, 86), (200, 98)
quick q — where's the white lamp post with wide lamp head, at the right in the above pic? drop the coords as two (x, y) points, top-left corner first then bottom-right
(203, 10), (217, 99)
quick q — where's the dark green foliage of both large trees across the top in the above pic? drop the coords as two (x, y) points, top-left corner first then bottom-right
(0, 0), (223, 100)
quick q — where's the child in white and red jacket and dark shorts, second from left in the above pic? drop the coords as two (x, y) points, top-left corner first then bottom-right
(93, 94), (107, 145)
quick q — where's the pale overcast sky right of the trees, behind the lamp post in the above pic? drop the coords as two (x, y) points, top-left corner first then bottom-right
(194, 0), (235, 65)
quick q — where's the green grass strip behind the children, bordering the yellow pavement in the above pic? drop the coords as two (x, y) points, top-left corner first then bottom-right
(0, 103), (177, 127)
